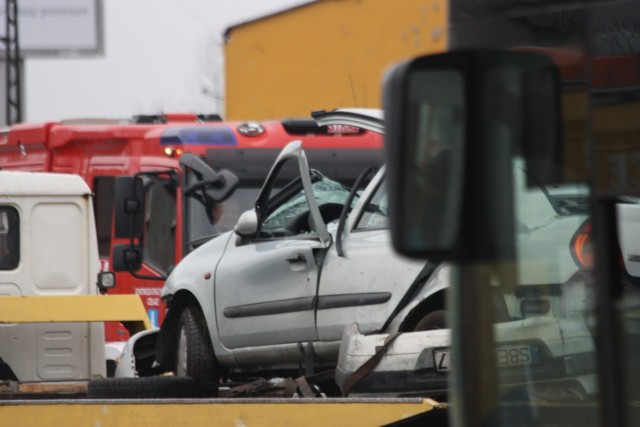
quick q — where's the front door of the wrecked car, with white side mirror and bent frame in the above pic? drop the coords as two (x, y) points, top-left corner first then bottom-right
(215, 141), (331, 348)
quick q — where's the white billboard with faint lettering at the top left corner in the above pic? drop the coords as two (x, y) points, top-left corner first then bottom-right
(0, 0), (103, 57)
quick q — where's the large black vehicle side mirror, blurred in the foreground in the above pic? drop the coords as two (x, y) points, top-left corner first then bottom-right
(384, 51), (561, 260)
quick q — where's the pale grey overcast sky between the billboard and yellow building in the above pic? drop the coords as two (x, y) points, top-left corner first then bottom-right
(23, 0), (309, 122)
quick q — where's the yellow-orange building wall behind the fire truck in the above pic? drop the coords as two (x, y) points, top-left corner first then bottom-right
(224, 0), (448, 120)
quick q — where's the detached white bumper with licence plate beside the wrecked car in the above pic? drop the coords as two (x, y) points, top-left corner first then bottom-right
(335, 316), (596, 399)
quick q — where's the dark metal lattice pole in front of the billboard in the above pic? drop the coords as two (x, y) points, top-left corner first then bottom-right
(2, 0), (22, 126)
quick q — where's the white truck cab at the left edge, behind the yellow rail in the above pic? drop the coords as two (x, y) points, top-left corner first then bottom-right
(0, 171), (106, 383)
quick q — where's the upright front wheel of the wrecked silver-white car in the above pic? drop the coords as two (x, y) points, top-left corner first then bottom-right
(175, 306), (220, 395)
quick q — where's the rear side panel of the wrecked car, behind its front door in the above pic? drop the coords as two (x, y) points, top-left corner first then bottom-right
(317, 169), (425, 341)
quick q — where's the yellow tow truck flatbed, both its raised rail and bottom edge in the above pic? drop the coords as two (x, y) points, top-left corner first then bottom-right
(0, 295), (446, 427)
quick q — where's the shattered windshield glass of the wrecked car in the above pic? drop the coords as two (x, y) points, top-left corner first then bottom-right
(262, 177), (357, 233)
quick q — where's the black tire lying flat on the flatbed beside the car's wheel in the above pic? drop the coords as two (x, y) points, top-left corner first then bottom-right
(87, 376), (210, 399)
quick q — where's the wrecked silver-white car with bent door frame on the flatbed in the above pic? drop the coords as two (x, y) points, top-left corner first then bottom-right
(149, 110), (584, 398)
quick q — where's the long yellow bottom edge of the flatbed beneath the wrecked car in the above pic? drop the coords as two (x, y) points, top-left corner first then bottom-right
(0, 398), (446, 427)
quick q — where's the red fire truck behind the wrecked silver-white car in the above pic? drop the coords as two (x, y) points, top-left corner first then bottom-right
(0, 114), (382, 372)
